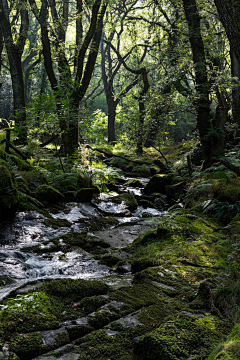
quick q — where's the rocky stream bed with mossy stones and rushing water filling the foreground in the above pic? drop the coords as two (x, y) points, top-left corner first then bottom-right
(0, 173), (239, 360)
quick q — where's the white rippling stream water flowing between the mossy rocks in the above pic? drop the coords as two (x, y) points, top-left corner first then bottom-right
(0, 180), (164, 299)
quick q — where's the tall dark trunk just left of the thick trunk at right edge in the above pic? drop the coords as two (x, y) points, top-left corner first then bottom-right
(183, 0), (213, 166)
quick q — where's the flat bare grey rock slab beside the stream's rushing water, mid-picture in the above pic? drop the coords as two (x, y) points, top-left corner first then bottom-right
(94, 225), (151, 248)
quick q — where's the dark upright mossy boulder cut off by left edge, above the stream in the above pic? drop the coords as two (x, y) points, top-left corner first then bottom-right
(0, 160), (19, 221)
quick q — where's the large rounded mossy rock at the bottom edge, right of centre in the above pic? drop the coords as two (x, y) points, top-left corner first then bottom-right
(134, 314), (227, 360)
